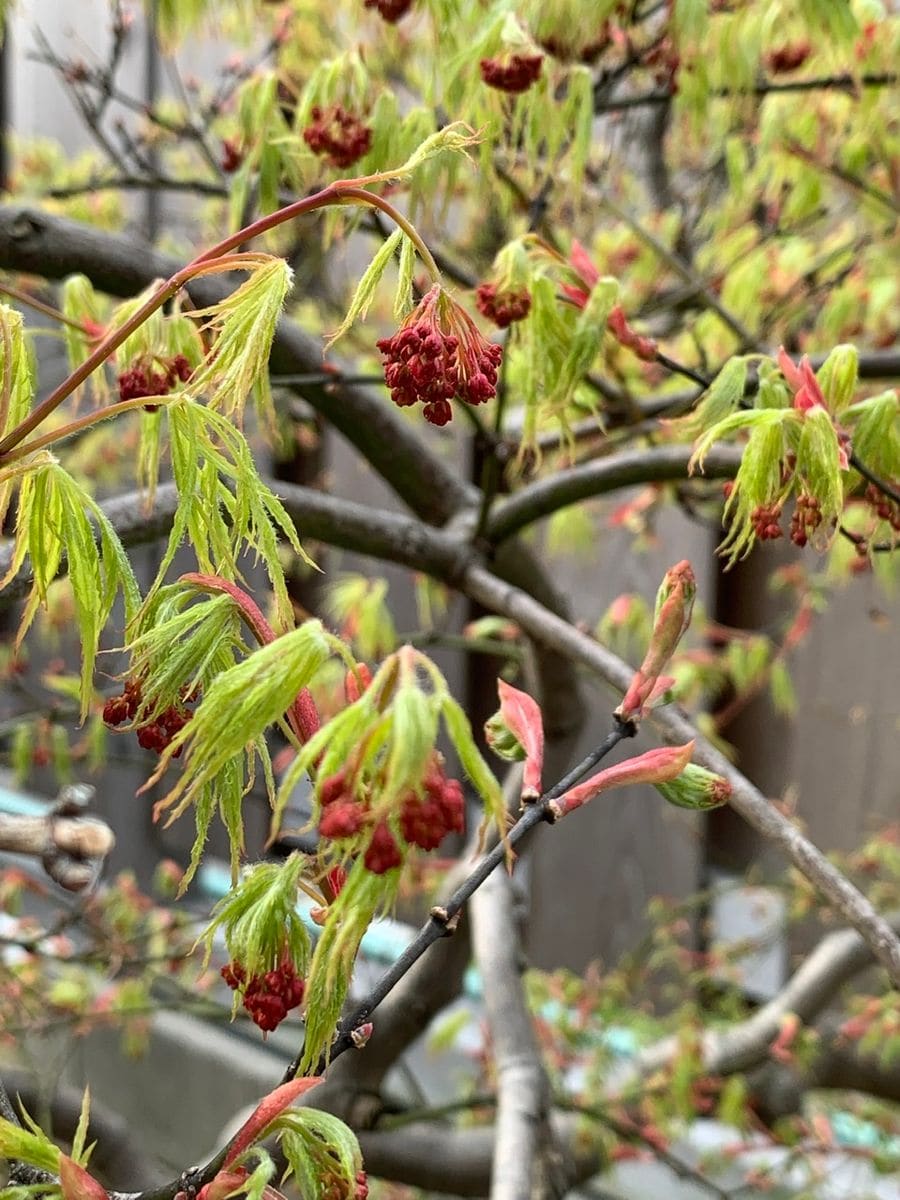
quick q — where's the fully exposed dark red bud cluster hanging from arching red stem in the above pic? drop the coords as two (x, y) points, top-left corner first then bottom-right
(377, 283), (503, 425)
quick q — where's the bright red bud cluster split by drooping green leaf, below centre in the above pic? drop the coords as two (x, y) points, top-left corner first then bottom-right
(319, 760), (466, 875)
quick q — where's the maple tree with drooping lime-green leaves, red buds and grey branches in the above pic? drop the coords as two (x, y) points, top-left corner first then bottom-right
(0, 0), (900, 1200)
